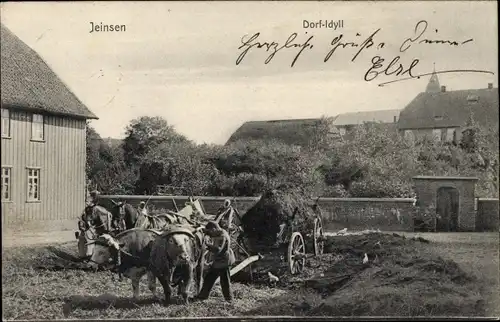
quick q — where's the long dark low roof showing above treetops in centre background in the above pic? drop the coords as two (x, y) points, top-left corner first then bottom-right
(227, 118), (340, 145)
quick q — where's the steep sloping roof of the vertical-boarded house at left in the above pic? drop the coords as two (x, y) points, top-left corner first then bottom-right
(1, 24), (97, 119)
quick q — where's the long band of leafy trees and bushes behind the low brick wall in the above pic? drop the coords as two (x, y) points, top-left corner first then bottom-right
(87, 117), (499, 198)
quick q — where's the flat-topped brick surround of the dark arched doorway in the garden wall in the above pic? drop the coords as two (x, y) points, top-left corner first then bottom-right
(414, 179), (476, 231)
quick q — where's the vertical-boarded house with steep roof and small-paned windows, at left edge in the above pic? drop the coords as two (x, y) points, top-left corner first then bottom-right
(1, 25), (97, 230)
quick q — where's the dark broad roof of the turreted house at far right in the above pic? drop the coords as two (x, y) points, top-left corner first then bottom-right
(398, 88), (498, 129)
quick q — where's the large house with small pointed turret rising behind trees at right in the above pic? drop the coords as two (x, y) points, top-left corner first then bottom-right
(398, 73), (499, 142)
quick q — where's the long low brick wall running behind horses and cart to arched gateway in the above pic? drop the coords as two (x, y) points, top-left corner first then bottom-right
(99, 196), (415, 231)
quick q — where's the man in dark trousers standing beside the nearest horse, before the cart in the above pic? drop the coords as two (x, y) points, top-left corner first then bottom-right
(197, 221), (235, 302)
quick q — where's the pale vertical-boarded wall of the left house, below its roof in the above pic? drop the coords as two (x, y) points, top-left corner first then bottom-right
(1, 110), (86, 230)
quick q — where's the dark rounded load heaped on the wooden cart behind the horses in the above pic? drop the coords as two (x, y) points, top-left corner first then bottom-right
(242, 186), (315, 251)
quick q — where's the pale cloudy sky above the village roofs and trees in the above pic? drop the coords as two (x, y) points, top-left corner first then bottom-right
(1, 1), (498, 144)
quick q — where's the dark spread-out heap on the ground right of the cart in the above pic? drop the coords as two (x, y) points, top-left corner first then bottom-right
(250, 233), (484, 316)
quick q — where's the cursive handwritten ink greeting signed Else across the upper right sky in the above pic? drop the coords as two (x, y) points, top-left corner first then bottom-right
(236, 20), (494, 86)
